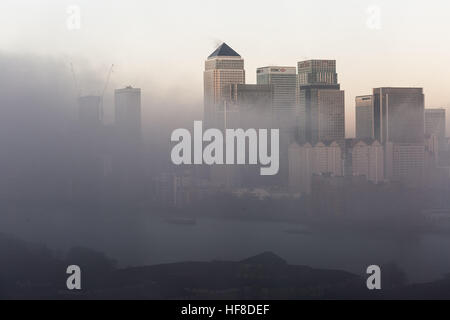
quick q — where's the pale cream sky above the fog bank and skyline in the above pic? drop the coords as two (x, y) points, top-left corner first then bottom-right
(0, 0), (450, 136)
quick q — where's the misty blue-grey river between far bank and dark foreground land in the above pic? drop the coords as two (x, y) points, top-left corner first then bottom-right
(0, 210), (450, 282)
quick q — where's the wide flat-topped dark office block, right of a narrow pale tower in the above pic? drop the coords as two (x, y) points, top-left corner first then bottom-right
(373, 88), (425, 143)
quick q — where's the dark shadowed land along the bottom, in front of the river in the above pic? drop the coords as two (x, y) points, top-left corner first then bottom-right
(0, 235), (450, 300)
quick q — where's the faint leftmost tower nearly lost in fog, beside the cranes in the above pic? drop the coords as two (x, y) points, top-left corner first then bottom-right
(78, 96), (103, 128)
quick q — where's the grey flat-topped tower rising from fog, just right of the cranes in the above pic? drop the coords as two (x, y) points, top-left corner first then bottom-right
(114, 86), (141, 142)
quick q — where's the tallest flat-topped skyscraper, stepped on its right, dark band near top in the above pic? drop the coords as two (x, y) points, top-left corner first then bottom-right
(297, 60), (345, 143)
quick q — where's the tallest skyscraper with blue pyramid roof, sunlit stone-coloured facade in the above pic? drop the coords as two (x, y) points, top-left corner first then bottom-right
(203, 43), (245, 127)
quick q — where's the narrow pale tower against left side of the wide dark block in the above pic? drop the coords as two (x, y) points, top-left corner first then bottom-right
(355, 95), (373, 139)
